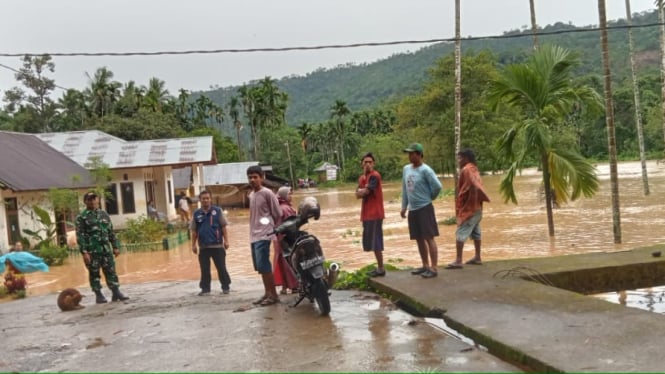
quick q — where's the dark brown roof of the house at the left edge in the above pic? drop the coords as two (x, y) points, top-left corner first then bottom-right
(0, 131), (94, 191)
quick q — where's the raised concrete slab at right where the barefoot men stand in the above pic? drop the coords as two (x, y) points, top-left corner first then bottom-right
(370, 245), (665, 372)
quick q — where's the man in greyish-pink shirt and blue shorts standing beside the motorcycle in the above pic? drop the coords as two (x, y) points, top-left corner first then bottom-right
(247, 165), (282, 306)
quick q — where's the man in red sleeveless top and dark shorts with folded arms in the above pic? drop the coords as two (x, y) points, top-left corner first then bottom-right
(356, 153), (386, 277)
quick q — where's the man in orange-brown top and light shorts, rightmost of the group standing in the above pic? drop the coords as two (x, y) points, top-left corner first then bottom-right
(446, 149), (490, 269)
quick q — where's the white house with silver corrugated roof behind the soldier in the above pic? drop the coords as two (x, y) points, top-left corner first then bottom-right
(35, 130), (217, 228)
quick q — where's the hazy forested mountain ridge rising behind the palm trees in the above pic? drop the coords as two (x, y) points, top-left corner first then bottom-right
(201, 11), (659, 126)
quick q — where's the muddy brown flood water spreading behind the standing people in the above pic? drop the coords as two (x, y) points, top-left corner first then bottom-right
(20, 161), (665, 295)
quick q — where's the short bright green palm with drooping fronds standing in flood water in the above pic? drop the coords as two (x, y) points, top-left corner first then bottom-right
(489, 46), (602, 236)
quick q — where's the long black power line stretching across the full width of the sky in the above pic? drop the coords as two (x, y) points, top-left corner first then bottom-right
(0, 22), (662, 57)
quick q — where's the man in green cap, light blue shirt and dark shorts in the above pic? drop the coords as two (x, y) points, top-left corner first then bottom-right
(400, 143), (442, 278)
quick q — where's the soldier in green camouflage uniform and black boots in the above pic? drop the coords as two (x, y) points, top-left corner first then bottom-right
(76, 192), (129, 304)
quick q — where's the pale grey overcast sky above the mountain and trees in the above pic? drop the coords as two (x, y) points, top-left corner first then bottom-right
(0, 0), (654, 97)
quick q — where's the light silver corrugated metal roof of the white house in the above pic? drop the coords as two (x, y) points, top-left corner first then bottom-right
(35, 130), (217, 169)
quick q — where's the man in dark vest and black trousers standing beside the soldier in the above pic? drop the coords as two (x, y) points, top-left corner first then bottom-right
(189, 190), (231, 296)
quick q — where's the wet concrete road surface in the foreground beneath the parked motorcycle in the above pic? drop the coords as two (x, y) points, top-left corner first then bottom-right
(0, 279), (520, 372)
